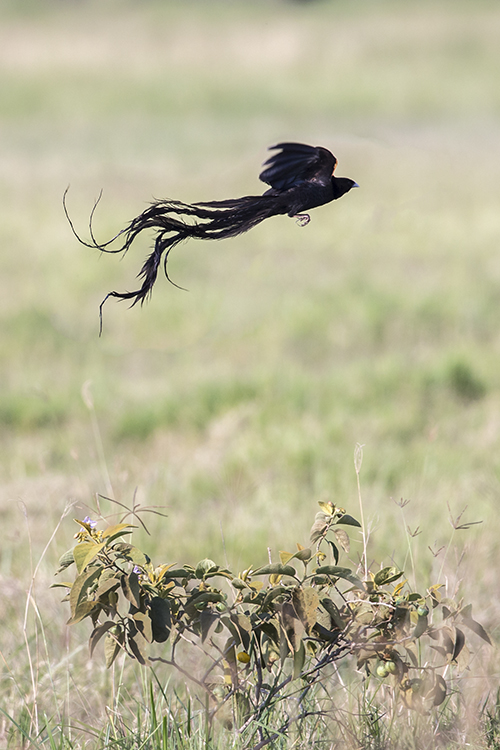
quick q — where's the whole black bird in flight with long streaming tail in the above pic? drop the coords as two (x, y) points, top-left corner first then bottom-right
(63, 143), (358, 322)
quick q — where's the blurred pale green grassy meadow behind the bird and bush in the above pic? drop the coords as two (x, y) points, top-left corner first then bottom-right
(0, 0), (500, 748)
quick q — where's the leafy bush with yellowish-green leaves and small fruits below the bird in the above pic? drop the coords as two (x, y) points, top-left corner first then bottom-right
(56, 502), (490, 747)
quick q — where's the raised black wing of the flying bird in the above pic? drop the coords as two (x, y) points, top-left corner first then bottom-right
(259, 143), (337, 190)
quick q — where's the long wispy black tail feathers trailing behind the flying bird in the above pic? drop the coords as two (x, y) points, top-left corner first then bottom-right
(63, 190), (286, 329)
